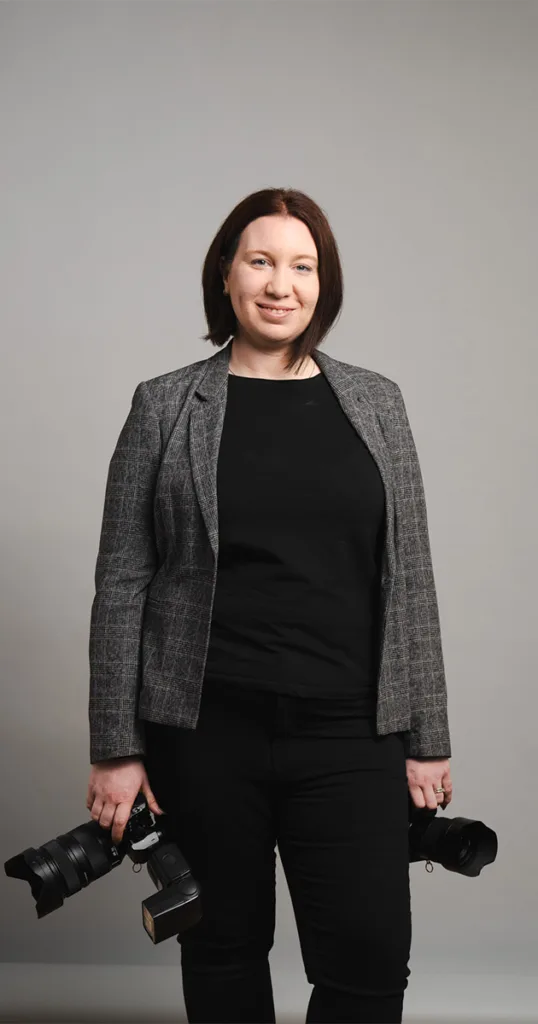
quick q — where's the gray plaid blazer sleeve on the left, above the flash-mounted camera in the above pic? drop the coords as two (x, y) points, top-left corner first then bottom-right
(88, 382), (161, 764)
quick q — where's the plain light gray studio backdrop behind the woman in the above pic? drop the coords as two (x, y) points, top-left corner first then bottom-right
(0, 0), (538, 1021)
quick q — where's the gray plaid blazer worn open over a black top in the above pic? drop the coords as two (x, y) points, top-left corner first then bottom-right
(89, 342), (451, 764)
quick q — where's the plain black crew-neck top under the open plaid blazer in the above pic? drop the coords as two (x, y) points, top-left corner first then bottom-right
(205, 373), (385, 718)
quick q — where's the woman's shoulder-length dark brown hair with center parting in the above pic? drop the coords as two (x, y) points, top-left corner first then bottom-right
(202, 188), (343, 370)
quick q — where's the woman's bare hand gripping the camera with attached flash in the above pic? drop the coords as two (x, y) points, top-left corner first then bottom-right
(86, 757), (164, 845)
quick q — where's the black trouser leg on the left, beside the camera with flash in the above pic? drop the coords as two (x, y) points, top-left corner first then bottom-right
(140, 690), (276, 1024)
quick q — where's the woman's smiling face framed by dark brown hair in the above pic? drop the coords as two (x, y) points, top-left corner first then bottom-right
(225, 214), (320, 343)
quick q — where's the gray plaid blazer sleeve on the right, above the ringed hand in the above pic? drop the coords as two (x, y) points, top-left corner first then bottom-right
(392, 385), (452, 759)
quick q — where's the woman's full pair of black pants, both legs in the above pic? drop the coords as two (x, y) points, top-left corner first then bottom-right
(146, 684), (411, 1024)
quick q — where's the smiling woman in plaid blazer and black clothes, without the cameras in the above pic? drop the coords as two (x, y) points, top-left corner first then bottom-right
(87, 188), (452, 1024)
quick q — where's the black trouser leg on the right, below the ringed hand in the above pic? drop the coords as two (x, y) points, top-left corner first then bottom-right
(276, 704), (411, 1024)
